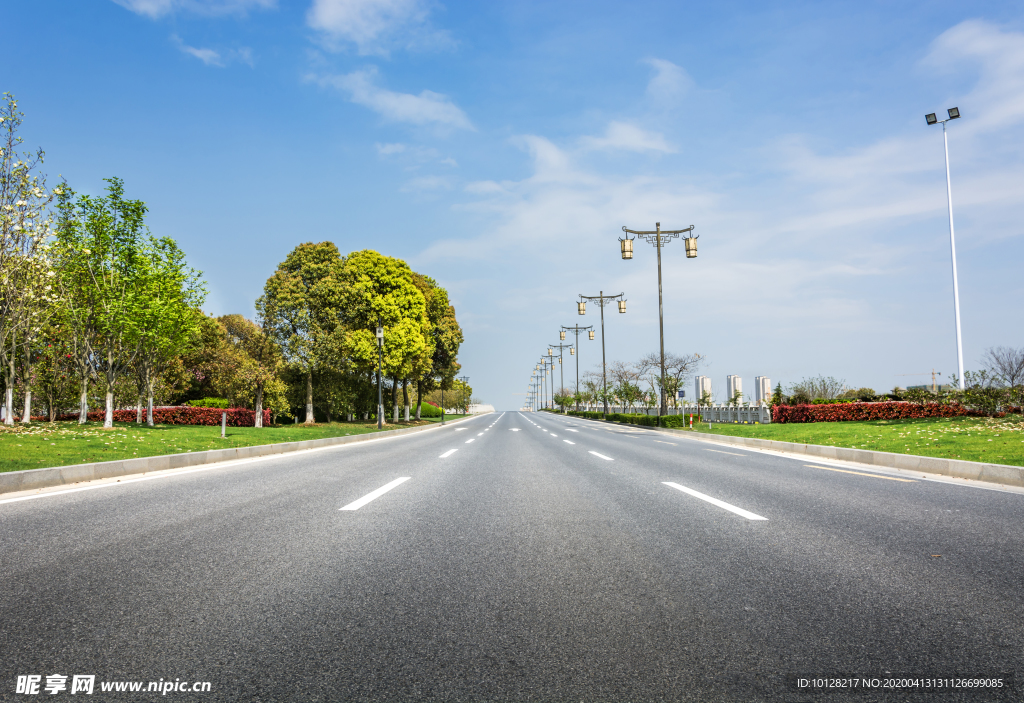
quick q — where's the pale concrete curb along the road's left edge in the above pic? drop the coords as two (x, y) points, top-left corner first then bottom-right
(0, 412), (488, 495)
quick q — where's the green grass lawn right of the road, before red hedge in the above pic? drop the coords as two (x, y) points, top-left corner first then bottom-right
(671, 414), (1024, 467)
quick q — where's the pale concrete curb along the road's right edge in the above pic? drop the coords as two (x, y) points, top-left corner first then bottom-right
(565, 415), (1024, 487)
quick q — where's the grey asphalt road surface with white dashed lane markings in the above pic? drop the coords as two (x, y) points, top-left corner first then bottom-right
(0, 412), (1024, 702)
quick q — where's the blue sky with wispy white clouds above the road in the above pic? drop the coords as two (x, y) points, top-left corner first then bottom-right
(0, 0), (1024, 408)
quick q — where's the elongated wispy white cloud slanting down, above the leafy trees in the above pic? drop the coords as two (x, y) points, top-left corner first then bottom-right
(311, 69), (474, 130)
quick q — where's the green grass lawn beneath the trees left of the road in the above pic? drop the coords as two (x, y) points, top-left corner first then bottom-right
(0, 415), (465, 472)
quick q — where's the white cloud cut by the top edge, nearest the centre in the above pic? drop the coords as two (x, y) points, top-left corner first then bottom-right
(306, 0), (450, 54)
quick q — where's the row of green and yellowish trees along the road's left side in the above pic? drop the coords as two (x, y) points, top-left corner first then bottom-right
(0, 94), (472, 437)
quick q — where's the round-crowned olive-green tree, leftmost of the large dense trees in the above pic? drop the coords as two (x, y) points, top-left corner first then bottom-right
(256, 241), (343, 425)
